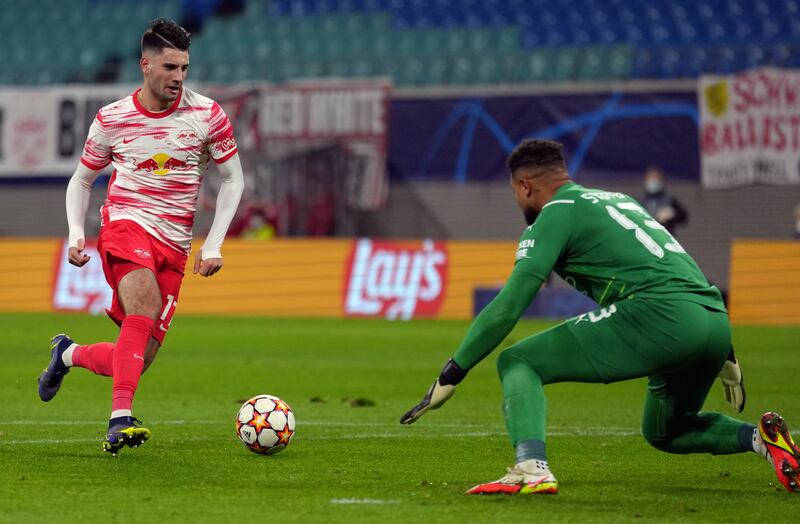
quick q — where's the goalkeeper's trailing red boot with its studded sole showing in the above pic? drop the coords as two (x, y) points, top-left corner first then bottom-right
(758, 412), (800, 493)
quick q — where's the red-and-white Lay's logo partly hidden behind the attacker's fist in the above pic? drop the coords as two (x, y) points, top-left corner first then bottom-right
(52, 241), (112, 314)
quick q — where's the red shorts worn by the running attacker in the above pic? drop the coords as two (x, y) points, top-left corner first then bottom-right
(97, 220), (186, 344)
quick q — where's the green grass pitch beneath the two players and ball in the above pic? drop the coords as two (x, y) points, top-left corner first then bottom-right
(0, 315), (800, 523)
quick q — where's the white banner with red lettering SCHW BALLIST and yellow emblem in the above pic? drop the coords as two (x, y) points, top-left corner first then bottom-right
(698, 68), (800, 188)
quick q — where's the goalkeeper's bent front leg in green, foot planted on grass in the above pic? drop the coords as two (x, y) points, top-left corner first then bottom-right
(471, 299), (727, 493)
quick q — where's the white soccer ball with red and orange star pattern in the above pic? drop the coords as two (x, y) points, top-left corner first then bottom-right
(236, 395), (294, 455)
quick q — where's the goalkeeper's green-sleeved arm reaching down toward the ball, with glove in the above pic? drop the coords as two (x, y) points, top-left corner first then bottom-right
(400, 203), (571, 424)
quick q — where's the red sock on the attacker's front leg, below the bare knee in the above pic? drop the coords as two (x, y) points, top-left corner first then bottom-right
(111, 315), (155, 412)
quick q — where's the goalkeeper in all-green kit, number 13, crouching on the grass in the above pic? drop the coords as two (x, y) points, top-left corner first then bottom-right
(400, 140), (800, 494)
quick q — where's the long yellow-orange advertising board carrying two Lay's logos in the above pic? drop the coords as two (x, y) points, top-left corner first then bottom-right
(0, 238), (516, 320)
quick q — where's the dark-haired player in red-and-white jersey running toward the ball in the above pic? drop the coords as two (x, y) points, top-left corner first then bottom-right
(39, 19), (244, 454)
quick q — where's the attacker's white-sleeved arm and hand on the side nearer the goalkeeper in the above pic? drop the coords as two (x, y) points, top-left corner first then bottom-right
(194, 153), (244, 277)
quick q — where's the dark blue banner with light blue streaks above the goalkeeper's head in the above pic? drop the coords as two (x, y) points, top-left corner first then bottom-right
(389, 92), (700, 183)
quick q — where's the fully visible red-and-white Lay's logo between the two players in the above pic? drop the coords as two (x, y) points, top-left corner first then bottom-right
(344, 239), (448, 320)
